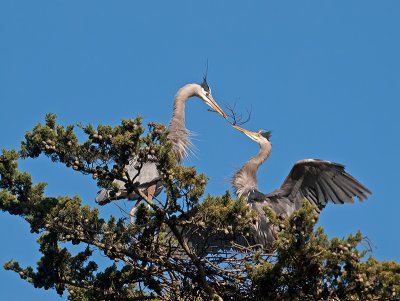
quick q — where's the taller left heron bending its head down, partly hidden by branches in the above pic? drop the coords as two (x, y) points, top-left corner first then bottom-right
(96, 77), (226, 221)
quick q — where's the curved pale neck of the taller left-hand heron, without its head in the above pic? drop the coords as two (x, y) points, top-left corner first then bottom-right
(168, 84), (196, 162)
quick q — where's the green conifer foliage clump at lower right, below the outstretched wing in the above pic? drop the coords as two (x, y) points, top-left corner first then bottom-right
(250, 202), (400, 300)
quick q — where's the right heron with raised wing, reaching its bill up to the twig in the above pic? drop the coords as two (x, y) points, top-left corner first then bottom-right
(232, 125), (371, 246)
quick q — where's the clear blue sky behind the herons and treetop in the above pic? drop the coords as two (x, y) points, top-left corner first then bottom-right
(0, 0), (400, 300)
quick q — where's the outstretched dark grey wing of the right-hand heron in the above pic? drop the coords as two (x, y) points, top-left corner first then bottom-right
(267, 159), (371, 209)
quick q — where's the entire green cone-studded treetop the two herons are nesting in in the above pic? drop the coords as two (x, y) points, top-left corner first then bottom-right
(0, 114), (400, 301)
